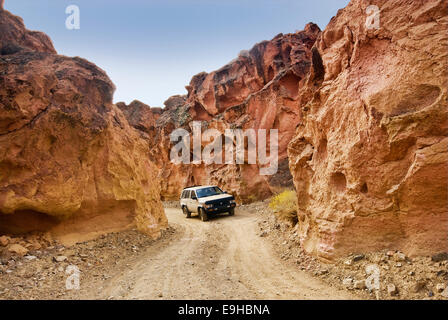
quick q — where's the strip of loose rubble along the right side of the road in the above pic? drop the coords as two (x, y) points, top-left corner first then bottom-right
(252, 200), (448, 300)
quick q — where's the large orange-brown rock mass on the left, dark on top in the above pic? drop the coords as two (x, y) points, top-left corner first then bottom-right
(0, 11), (167, 242)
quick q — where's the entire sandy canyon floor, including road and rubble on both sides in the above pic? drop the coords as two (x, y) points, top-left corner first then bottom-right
(0, 202), (448, 300)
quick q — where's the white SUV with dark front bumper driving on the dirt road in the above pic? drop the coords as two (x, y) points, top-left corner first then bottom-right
(180, 186), (236, 221)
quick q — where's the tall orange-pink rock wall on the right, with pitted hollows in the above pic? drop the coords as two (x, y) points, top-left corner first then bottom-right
(289, 0), (448, 258)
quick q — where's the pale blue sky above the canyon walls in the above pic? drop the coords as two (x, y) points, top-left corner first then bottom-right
(5, 0), (349, 106)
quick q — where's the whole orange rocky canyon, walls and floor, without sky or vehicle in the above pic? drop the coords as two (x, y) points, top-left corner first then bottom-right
(0, 0), (448, 299)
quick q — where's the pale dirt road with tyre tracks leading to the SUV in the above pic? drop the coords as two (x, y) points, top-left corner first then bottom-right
(95, 208), (354, 299)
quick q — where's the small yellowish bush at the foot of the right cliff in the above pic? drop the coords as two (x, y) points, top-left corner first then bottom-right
(269, 190), (298, 226)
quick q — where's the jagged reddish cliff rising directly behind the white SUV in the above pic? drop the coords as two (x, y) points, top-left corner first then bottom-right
(122, 23), (320, 202)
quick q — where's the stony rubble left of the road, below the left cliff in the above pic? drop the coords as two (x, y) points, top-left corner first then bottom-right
(0, 227), (175, 300)
